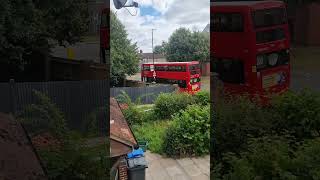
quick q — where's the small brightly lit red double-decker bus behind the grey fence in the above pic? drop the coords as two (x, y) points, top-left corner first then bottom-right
(141, 61), (201, 94)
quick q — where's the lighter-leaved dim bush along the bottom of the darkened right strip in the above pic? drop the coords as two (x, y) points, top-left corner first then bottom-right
(212, 137), (320, 180)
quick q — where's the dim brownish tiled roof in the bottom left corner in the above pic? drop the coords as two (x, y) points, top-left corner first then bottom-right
(0, 113), (47, 180)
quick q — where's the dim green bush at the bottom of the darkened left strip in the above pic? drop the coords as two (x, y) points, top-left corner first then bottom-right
(38, 136), (108, 180)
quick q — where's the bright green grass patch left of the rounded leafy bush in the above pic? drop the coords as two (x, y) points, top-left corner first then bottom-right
(132, 120), (171, 154)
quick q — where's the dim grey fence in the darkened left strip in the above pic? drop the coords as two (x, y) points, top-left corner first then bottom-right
(0, 80), (109, 130)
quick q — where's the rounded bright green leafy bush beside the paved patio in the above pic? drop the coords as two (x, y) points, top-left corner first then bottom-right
(163, 105), (210, 157)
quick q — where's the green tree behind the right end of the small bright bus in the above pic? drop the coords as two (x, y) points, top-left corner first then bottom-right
(166, 28), (210, 62)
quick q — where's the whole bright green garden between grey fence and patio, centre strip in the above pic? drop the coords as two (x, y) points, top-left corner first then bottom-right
(117, 91), (210, 158)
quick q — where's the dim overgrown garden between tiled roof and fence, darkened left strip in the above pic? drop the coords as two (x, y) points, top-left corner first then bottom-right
(17, 91), (109, 180)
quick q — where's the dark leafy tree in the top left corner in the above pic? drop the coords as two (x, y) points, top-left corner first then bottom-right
(0, 0), (88, 68)
